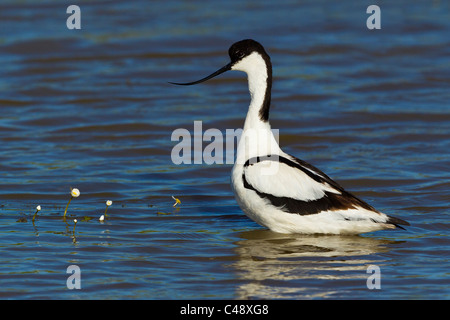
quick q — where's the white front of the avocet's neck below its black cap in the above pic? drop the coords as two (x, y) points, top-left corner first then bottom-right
(232, 52), (281, 163)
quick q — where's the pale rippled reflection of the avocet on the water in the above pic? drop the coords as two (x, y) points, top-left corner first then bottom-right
(232, 230), (397, 299)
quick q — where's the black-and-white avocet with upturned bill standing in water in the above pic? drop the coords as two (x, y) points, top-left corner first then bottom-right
(174, 39), (409, 234)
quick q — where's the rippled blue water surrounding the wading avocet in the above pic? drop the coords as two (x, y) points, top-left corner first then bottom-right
(0, 0), (450, 299)
